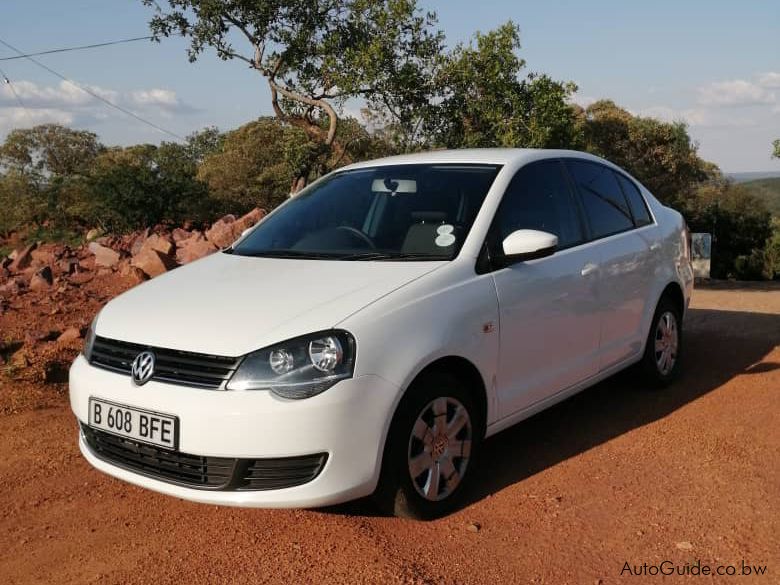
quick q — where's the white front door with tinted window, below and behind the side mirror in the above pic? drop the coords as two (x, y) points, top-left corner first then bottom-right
(488, 160), (601, 417)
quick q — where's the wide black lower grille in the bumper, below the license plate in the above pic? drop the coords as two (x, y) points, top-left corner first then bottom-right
(81, 423), (328, 491)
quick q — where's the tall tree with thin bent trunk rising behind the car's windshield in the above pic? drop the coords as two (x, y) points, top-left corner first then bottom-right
(143, 0), (442, 191)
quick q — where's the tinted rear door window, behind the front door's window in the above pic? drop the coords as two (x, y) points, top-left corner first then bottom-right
(566, 160), (634, 239)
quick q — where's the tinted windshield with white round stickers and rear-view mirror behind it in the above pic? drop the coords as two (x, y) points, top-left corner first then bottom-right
(230, 164), (500, 260)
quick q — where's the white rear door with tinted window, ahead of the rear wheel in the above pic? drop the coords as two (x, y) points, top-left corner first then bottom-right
(566, 159), (658, 370)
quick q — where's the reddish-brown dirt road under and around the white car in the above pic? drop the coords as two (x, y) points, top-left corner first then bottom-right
(0, 285), (780, 585)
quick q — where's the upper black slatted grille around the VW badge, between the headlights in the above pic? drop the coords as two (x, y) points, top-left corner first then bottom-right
(90, 337), (241, 389)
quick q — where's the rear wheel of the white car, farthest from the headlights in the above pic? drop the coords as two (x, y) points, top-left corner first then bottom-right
(642, 297), (682, 386)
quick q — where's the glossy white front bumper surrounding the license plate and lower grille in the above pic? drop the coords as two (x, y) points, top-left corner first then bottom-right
(70, 355), (400, 507)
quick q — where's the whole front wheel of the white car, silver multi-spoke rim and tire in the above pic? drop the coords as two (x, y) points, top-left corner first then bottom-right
(375, 372), (484, 519)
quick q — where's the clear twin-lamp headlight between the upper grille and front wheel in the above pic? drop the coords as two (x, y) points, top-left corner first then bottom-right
(227, 330), (355, 399)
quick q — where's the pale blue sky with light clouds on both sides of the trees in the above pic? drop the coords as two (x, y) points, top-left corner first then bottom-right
(0, 0), (780, 172)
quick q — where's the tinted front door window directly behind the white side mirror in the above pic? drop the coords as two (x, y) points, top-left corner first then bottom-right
(491, 161), (584, 255)
